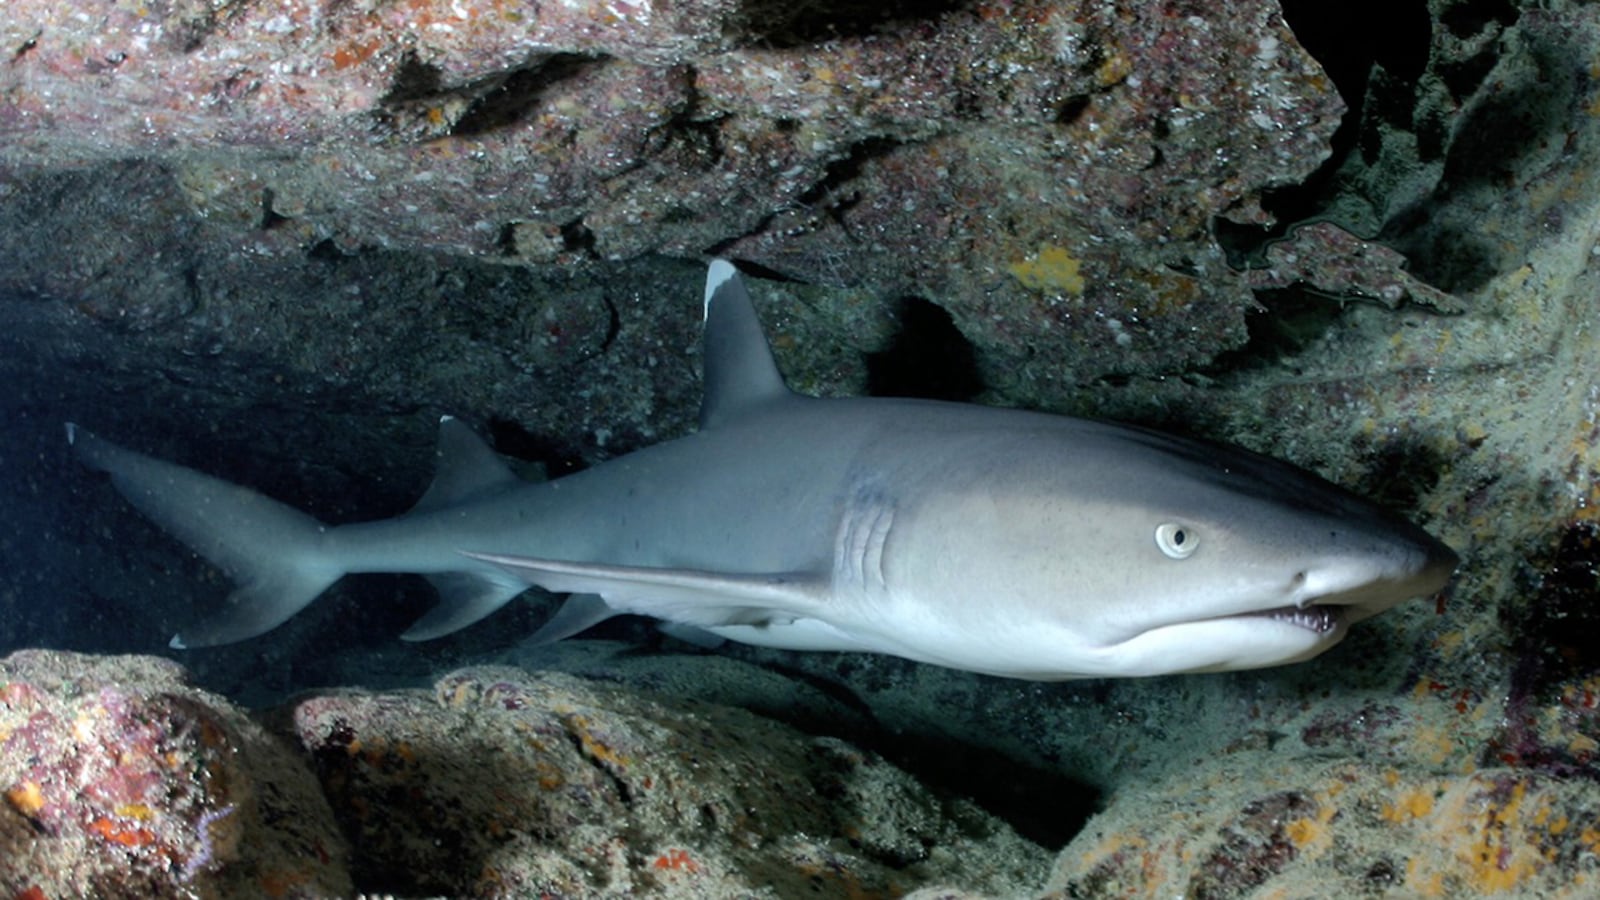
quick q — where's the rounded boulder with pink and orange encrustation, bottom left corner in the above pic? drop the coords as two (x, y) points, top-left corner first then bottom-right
(0, 650), (352, 900)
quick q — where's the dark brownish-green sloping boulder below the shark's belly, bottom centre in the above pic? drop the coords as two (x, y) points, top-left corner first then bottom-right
(284, 668), (1048, 897)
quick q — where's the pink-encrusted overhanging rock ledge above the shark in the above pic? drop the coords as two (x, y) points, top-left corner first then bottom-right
(0, 0), (1342, 386)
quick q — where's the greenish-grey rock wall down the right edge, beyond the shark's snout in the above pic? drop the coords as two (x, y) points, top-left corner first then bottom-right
(1030, 3), (1600, 897)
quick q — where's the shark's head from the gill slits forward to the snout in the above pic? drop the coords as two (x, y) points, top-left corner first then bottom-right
(890, 421), (1458, 679)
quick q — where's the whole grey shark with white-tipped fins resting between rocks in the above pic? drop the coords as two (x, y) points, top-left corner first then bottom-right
(67, 261), (1458, 681)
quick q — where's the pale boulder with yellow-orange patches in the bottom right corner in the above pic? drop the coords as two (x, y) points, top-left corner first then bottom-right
(1043, 756), (1600, 900)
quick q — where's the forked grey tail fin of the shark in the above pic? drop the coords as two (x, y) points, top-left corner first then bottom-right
(67, 423), (344, 649)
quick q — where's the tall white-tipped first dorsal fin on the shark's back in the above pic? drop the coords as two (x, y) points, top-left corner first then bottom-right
(701, 259), (789, 429)
